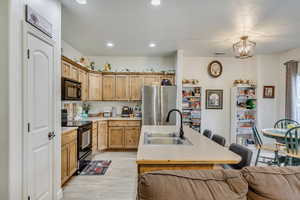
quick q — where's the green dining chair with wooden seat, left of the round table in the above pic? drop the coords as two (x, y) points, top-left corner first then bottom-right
(252, 126), (280, 166)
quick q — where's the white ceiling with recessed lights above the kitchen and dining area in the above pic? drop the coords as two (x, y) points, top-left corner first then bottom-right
(61, 0), (300, 56)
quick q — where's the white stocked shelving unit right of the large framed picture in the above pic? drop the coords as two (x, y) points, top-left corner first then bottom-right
(231, 85), (257, 145)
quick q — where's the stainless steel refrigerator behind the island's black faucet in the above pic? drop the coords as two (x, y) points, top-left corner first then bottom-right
(142, 86), (177, 125)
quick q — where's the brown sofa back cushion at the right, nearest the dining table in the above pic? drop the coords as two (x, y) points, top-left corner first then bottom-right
(242, 166), (300, 200)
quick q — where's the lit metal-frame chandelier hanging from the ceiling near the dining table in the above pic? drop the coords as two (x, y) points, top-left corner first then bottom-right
(233, 36), (256, 59)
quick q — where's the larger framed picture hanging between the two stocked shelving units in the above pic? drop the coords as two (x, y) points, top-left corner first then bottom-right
(206, 90), (223, 109)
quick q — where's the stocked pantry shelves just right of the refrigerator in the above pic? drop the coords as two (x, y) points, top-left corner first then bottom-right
(182, 85), (201, 132)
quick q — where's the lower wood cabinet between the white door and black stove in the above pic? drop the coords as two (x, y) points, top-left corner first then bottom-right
(61, 130), (77, 185)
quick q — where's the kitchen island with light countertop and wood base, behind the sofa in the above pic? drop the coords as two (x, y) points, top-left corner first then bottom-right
(136, 126), (241, 174)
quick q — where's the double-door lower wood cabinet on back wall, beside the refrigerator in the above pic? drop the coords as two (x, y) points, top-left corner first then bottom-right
(108, 122), (140, 149)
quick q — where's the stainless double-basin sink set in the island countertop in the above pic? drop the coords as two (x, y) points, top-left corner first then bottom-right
(144, 133), (192, 145)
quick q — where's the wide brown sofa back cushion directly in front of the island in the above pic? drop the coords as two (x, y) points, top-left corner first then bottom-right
(138, 170), (248, 200)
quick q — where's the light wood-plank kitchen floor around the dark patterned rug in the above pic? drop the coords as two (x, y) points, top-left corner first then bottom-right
(63, 152), (137, 200)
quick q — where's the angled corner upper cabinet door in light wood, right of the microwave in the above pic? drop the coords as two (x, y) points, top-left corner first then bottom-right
(88, 73), (102, 101)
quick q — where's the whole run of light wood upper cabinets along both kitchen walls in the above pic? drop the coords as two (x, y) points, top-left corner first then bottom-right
(61, 56), (175, 101)
